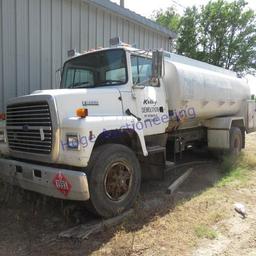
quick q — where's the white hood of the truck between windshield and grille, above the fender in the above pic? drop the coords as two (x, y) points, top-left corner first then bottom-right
(31, 88), (123, 120)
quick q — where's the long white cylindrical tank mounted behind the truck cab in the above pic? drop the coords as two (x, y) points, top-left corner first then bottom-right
(163, 53), (250, 120)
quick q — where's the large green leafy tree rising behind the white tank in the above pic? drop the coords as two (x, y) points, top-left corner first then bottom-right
(156, 0), (256, 73)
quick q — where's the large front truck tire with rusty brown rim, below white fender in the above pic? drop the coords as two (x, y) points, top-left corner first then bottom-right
(87, 144), (141, 218)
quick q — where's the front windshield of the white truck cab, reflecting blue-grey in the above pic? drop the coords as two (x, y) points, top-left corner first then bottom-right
(61, 49), (127, 88)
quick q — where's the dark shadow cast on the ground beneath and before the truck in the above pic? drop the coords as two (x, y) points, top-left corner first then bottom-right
(0, 152), (222, 256)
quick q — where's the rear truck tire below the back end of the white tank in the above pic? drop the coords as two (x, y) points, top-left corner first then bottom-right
(229, 127), (243, 155)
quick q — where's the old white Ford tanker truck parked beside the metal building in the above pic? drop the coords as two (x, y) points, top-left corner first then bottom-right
(0, 40), (256, 218)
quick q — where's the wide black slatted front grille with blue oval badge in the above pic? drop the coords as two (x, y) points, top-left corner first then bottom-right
(6, 102), (52, 154)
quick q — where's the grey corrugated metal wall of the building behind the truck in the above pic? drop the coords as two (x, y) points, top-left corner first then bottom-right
(0, 0), (172, 111)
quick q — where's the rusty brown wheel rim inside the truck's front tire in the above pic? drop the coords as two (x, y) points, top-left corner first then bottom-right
(104, 162), (132, 201)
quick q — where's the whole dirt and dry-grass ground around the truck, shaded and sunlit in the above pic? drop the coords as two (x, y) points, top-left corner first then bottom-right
(0, 134), (256, 256)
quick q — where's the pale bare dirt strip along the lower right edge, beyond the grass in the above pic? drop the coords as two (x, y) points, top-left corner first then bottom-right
(193, 133), (256, 256)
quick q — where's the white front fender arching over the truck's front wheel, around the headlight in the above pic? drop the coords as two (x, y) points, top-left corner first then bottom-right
(58, 116), (148, 167)
